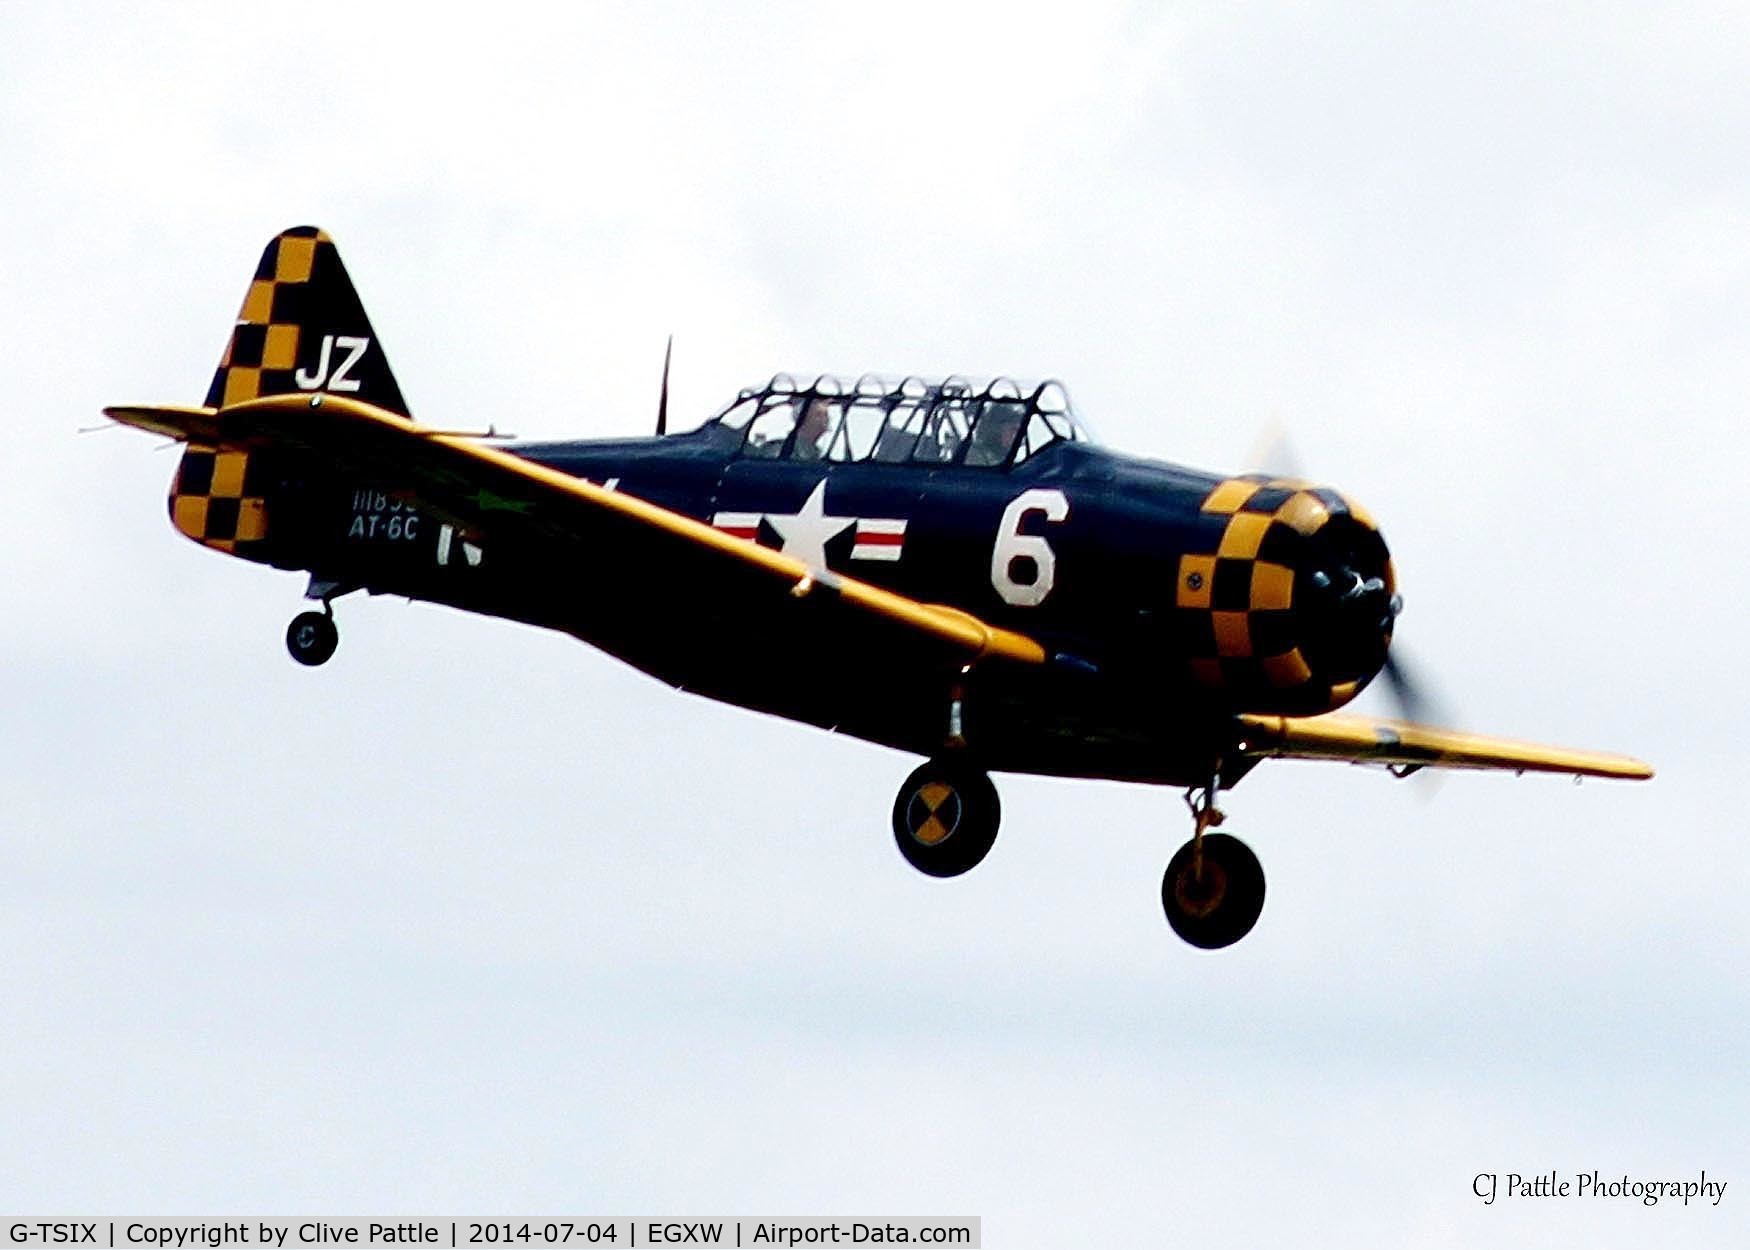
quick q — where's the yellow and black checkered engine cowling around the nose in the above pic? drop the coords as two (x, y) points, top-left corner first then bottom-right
(1174, 476), (1374, 707)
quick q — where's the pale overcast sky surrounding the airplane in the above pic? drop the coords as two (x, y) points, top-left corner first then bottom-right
(0, 0), (1750, 1248)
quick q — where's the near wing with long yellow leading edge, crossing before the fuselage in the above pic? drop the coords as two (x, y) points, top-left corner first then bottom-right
(103, 394), (1047, 665)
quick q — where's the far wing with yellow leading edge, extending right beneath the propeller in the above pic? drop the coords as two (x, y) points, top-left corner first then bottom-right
(1239, 714), (1652, 781)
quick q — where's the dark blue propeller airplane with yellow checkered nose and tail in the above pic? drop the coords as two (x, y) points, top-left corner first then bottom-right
(105, 226), (1652, 949)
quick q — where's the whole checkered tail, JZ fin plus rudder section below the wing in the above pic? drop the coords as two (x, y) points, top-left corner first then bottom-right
(170, 226), (408, 558)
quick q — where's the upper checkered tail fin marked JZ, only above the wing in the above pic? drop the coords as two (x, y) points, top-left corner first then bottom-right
(207, 226), (408, 417)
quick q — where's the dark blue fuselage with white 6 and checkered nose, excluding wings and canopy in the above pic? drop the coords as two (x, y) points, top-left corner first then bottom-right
(191, 385), (1391, 784)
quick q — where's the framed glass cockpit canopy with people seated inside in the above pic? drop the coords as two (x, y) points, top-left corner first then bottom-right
(705, 373), (1089, 469)
